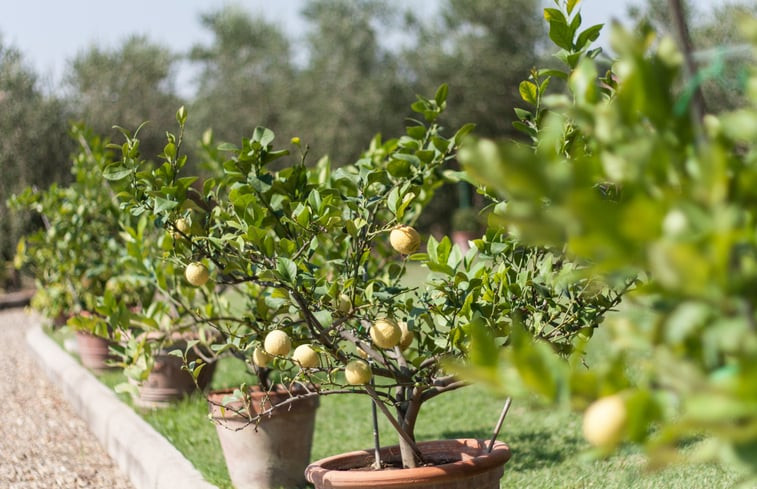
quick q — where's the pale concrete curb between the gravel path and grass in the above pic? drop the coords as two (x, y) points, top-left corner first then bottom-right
(26, 325), (217, 489)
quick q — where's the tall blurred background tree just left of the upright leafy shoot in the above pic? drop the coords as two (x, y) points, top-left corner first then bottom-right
(402, 0), (544, 234)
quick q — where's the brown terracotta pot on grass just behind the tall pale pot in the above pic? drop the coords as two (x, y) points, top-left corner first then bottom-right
(134, 342), (216, 407)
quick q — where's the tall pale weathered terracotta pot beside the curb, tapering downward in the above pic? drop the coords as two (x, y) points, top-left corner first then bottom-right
(209, 386), (318, 489)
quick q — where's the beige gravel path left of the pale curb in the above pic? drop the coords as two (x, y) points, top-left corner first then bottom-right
(0, 309), (133, 489)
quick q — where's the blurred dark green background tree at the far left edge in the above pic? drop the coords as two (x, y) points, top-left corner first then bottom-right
(0, 39), (71, 274)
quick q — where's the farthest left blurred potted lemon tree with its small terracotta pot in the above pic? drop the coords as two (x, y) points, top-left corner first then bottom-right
(9, 126), (130, 370)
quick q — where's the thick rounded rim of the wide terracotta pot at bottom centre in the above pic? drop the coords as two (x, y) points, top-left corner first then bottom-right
(305, 438), (511, 488)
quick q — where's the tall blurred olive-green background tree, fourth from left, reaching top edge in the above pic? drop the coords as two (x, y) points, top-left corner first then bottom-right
(287, 0), (414, 166)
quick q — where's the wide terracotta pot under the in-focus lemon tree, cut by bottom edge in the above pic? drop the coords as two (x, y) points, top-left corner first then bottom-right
(305, 438), (510, 489)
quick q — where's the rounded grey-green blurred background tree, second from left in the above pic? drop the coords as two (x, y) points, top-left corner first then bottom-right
(64, 36), (181, 162)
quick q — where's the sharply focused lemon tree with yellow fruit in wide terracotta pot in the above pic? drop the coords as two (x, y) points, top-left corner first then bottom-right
(104, 76), (619, 487)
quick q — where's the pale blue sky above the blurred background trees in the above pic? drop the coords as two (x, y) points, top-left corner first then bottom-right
(0, 0), (726, 95)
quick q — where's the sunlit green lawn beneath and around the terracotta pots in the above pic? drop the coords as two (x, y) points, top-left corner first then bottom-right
(90, 350), (735, 489)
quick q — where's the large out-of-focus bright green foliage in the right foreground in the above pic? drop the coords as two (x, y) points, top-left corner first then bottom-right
(463, 2), (757, 480)
